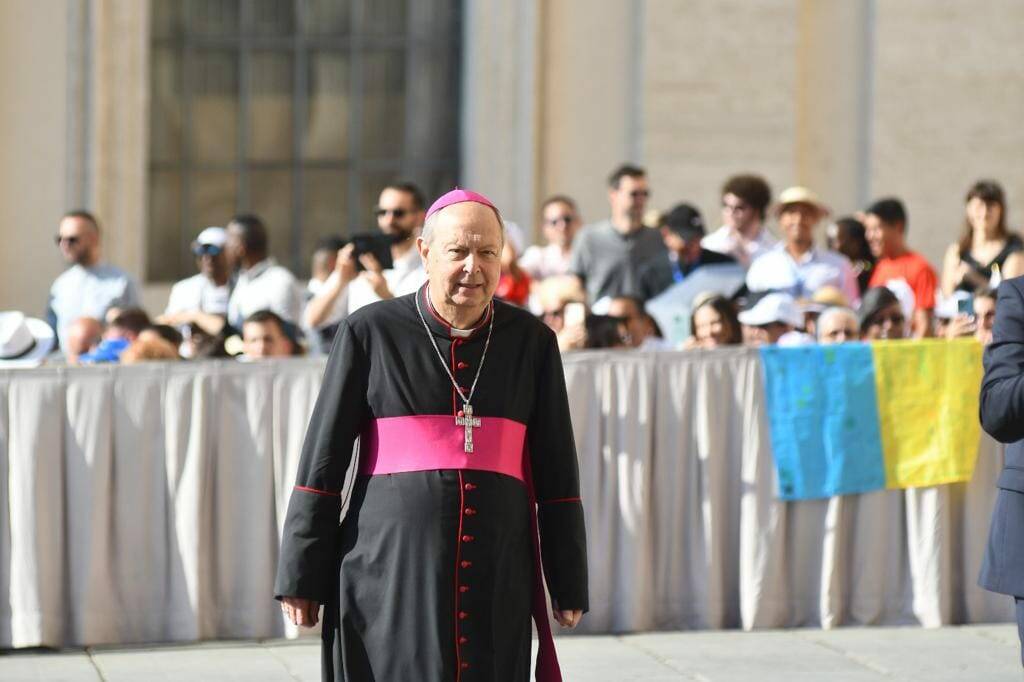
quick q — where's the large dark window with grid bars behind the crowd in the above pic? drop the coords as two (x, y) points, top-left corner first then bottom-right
(146, 0), (462, 282)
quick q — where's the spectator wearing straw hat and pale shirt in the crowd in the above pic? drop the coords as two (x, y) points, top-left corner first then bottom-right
(746, 187), (860, 306)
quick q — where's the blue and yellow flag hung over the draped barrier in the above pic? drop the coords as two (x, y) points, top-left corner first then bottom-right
(761, 339), (982, 500)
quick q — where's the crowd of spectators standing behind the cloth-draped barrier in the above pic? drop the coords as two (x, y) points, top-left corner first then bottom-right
(0, 165), (1007, 366)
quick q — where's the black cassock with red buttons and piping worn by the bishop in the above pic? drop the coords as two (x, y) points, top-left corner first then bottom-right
(274, 287), (588, 682)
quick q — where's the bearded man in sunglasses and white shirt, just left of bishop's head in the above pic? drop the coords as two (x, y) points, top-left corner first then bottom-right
(302, 182), (427, 330)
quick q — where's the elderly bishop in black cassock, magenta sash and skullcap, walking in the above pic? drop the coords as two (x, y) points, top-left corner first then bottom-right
(274, 189), (588, 682)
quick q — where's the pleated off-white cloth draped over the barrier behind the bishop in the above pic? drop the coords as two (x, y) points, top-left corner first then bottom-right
(0, 350), (1013, 647)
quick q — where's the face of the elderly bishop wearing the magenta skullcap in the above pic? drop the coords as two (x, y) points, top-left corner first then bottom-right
(420, 202), (504, 310)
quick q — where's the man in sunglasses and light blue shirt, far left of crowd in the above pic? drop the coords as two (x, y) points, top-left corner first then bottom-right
(46, 211), (139, 346)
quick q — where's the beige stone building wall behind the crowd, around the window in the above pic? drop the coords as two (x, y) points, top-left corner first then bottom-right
(0, 0), (1024, 313)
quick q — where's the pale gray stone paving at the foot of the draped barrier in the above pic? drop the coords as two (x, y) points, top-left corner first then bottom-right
(0, 626), (1024, 682)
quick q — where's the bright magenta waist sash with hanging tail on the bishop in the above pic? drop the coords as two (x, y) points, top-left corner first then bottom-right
(359, 415), (562, 682)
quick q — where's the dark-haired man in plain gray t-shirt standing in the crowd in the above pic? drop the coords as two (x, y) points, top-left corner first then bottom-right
(569, 166), (665, 304)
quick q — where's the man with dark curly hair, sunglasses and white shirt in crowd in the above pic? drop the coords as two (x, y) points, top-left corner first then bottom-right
(700, 175), (778, 267)
